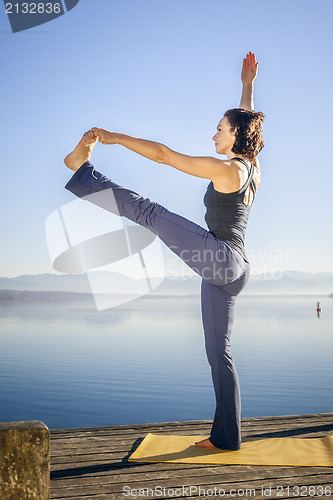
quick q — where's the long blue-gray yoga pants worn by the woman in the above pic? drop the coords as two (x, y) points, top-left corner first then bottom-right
(65, 162), (250, 450)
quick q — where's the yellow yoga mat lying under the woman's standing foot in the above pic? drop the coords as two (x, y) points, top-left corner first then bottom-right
(129, 433), (333, 467)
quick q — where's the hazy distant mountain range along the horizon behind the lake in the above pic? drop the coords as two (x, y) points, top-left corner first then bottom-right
(0, 271), (333, 295)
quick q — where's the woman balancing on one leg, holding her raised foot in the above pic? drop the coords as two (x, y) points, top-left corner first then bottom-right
(65, 52), (264, 450)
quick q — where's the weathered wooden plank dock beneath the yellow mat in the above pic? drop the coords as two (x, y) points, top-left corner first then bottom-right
(50, 413), (333, 500)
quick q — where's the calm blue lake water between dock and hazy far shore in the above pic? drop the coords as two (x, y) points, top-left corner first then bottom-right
(0, 296), (333, 429)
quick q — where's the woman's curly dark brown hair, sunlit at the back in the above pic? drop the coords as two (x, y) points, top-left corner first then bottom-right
(224, 108), (265, 161)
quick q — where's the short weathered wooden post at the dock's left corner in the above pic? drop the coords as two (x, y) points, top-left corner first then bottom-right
(0, 420), (50, 500)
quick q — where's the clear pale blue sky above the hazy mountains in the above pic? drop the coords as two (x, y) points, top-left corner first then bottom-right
(0, 0), (333, 277)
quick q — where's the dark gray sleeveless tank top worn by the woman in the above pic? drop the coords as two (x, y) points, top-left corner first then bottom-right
(203, 157), (256, 263)
